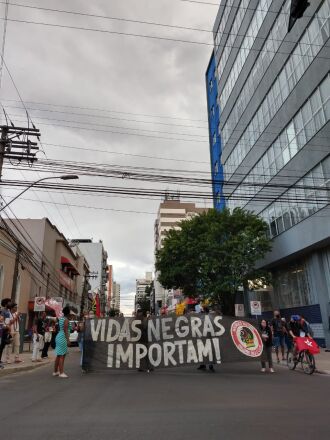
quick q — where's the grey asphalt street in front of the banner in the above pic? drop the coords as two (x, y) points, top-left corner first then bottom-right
(0, 349), (330, 440)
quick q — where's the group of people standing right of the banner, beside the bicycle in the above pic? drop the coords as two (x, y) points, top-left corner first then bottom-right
(260, 310), (313, 373)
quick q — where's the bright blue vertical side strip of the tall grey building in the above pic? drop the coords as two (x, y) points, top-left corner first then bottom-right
(205, 52), (225, 211)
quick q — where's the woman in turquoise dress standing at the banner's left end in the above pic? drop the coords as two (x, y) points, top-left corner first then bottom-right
(53, 306), (71, 379)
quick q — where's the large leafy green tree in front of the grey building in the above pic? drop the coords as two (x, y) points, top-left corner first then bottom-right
(156, 208), (271, 314)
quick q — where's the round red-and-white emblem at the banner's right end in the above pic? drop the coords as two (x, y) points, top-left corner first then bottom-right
(230, 321), (263, 357)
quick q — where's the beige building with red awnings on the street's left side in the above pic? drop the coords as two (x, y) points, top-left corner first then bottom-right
(1, 218), (89, 321)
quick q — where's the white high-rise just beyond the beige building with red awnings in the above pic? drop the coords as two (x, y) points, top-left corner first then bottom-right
(71, 238), (108, 313)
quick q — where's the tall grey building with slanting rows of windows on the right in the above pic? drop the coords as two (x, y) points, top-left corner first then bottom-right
(206, 0), (330, 346)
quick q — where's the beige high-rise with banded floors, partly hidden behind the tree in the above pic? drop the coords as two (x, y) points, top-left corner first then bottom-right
(154, 195), (208, 313)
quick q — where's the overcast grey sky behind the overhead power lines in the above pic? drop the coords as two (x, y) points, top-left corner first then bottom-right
(0, 0), (217, 312)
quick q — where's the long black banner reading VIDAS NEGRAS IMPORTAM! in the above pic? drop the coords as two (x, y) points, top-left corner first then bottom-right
(83, 313), (263, 371)
